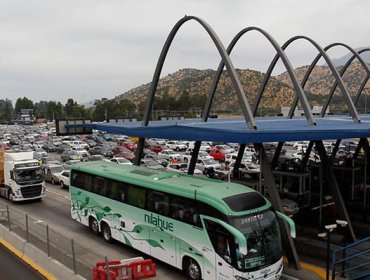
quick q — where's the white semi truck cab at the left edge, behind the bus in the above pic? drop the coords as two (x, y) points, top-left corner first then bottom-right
(0, 151), (45, 201)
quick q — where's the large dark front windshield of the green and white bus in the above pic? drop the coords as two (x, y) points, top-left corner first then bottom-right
(231, 210), (282, 271)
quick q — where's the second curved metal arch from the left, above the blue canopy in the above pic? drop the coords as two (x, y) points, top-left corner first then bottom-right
(203, 26), (316, 125)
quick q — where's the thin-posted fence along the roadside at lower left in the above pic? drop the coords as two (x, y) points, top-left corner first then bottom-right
(0, 202), (106, 279)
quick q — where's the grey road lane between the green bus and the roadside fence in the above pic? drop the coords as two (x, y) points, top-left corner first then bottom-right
(0, 183), (186, 280)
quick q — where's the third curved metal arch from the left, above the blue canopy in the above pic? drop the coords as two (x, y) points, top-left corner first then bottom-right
(253, 36), (360, 122)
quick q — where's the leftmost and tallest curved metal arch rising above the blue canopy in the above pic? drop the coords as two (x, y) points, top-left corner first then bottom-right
(143, 16), (257, 129)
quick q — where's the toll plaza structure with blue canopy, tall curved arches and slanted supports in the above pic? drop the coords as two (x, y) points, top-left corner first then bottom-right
(61, 16), (370, 274)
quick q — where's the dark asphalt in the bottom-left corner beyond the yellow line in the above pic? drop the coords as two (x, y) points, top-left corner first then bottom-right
(0, 242), (45, 280)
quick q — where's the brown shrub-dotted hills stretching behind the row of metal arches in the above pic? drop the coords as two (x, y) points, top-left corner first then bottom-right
(116, 62), (370, 112)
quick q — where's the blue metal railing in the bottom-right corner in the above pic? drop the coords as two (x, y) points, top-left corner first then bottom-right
(332, 237), (370, 279)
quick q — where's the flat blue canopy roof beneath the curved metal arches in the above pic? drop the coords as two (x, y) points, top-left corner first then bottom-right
(66, 115), (370, 143)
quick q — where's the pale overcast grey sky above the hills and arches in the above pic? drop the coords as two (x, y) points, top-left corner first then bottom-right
(0, 0), (370, 105)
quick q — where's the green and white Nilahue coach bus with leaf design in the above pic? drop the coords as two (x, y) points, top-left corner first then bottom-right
(69, 161), (295, 280)
